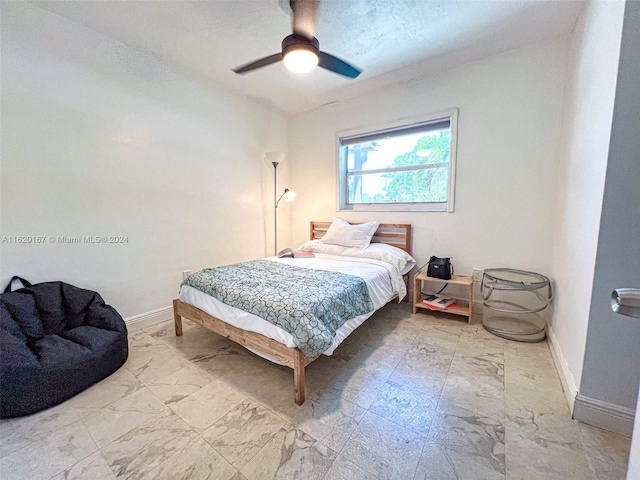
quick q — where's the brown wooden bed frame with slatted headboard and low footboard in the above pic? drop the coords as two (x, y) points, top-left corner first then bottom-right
(173, 222), (411, 405)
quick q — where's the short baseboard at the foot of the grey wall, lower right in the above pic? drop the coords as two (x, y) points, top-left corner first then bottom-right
(573, 394), (635, 437)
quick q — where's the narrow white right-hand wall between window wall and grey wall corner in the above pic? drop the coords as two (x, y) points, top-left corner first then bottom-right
(550, 2), (624, 402)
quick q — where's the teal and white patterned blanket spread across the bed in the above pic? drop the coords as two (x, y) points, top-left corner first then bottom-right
(182, 260), (373, 360)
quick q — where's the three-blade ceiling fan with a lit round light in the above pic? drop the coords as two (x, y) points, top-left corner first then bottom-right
(233, 0), (362, 78)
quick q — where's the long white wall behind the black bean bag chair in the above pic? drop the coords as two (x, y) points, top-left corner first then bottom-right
(0, 2), (288, 317)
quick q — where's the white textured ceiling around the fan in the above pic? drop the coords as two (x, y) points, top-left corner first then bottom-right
(32, 0), (584, 114)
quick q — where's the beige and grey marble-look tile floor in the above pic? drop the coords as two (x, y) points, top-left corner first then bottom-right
(0, 303), (630, 480)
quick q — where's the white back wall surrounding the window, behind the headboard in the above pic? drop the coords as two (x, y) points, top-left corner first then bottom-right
(288, 38), (568, 296)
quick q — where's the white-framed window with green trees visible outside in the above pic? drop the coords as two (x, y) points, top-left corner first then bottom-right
(338, 110), (458, 212)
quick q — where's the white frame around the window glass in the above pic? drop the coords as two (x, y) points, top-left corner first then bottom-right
(336, 108), (458, 212)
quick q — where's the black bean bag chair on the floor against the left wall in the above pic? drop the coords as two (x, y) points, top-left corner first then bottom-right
(0, 277), (129, 418)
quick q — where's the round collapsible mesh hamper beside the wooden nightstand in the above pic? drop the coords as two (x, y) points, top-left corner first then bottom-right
(480, 268), (553, 342)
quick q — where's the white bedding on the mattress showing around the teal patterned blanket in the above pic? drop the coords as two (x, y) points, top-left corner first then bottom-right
(179, 254), (406, 363)
